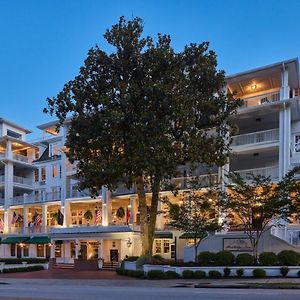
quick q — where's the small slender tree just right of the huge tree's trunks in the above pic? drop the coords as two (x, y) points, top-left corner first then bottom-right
(168, 189), (223, 261)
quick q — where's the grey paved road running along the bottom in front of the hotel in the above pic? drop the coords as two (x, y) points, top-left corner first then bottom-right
(0, 279), (300, 300)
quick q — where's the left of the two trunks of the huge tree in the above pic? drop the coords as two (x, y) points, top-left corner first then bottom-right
(136, 176), (151, 255)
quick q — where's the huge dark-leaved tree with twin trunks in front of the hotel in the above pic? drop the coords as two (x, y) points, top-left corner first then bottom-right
(45, 17), (238, 254)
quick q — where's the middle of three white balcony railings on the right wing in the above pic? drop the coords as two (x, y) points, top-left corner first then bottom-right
(231, 128), (279, 146)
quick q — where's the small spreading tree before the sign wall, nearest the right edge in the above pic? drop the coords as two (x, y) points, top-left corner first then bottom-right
(226, 168), (300, 263)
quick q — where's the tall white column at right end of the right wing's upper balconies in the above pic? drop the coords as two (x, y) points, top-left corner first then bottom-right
(279, 69), (291, 179)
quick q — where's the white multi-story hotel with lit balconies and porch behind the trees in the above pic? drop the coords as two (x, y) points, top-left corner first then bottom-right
(0, 59), (300, 263)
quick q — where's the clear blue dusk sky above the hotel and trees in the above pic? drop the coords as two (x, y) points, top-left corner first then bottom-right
(0, 0), (300, 138)
